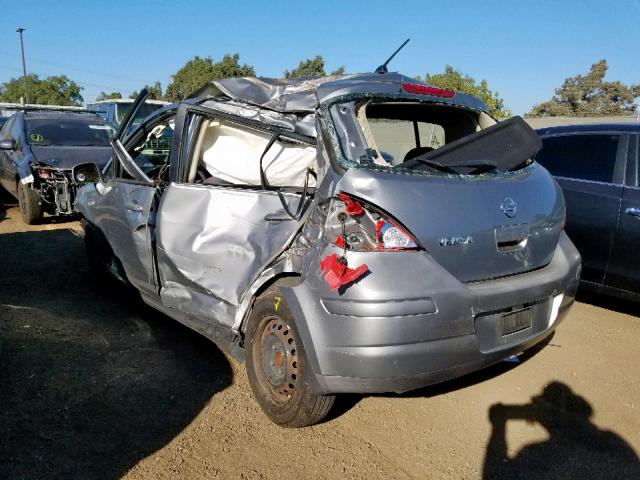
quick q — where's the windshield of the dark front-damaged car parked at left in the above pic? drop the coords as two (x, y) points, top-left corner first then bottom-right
(25, 116), (113, 147)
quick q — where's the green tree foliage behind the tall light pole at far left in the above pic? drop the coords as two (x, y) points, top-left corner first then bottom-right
(0, 73), (83, 106)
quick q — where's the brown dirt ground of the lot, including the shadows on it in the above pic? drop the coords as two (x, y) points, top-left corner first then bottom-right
(0, 195), (640, 480)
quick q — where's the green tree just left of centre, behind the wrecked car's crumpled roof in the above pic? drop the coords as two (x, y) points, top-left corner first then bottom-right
(165, 53), (256, 101)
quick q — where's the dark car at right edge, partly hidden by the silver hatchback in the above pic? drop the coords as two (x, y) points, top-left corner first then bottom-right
(536, 123), (640, 299)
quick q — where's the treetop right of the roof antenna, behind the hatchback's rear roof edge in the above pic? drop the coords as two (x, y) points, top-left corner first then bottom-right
(418, 65), (511, 118)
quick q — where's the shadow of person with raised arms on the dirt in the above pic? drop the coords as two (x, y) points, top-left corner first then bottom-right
(483, 382), (640, 480)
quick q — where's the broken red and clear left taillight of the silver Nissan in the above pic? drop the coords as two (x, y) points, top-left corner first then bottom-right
(325, 193), (419, 251)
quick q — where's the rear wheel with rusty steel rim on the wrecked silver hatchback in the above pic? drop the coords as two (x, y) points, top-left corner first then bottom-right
(246, 289), (335, 427)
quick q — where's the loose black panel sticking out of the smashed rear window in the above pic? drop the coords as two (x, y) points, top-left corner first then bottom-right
(401, 117), (542, 174)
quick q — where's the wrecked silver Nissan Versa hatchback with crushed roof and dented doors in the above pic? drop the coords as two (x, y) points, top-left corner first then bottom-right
(74, 74), (580, 427)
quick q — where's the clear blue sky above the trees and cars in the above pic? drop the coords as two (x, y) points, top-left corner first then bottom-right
(0, 0), (640, 114)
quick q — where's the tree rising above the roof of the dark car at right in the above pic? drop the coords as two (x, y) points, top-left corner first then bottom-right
(527, 60), (640, 117)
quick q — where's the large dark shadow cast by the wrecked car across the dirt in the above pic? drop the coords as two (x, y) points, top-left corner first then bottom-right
(0, 230), (233, 479)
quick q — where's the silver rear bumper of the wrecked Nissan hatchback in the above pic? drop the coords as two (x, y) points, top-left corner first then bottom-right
(281, 234), (580, 393)
